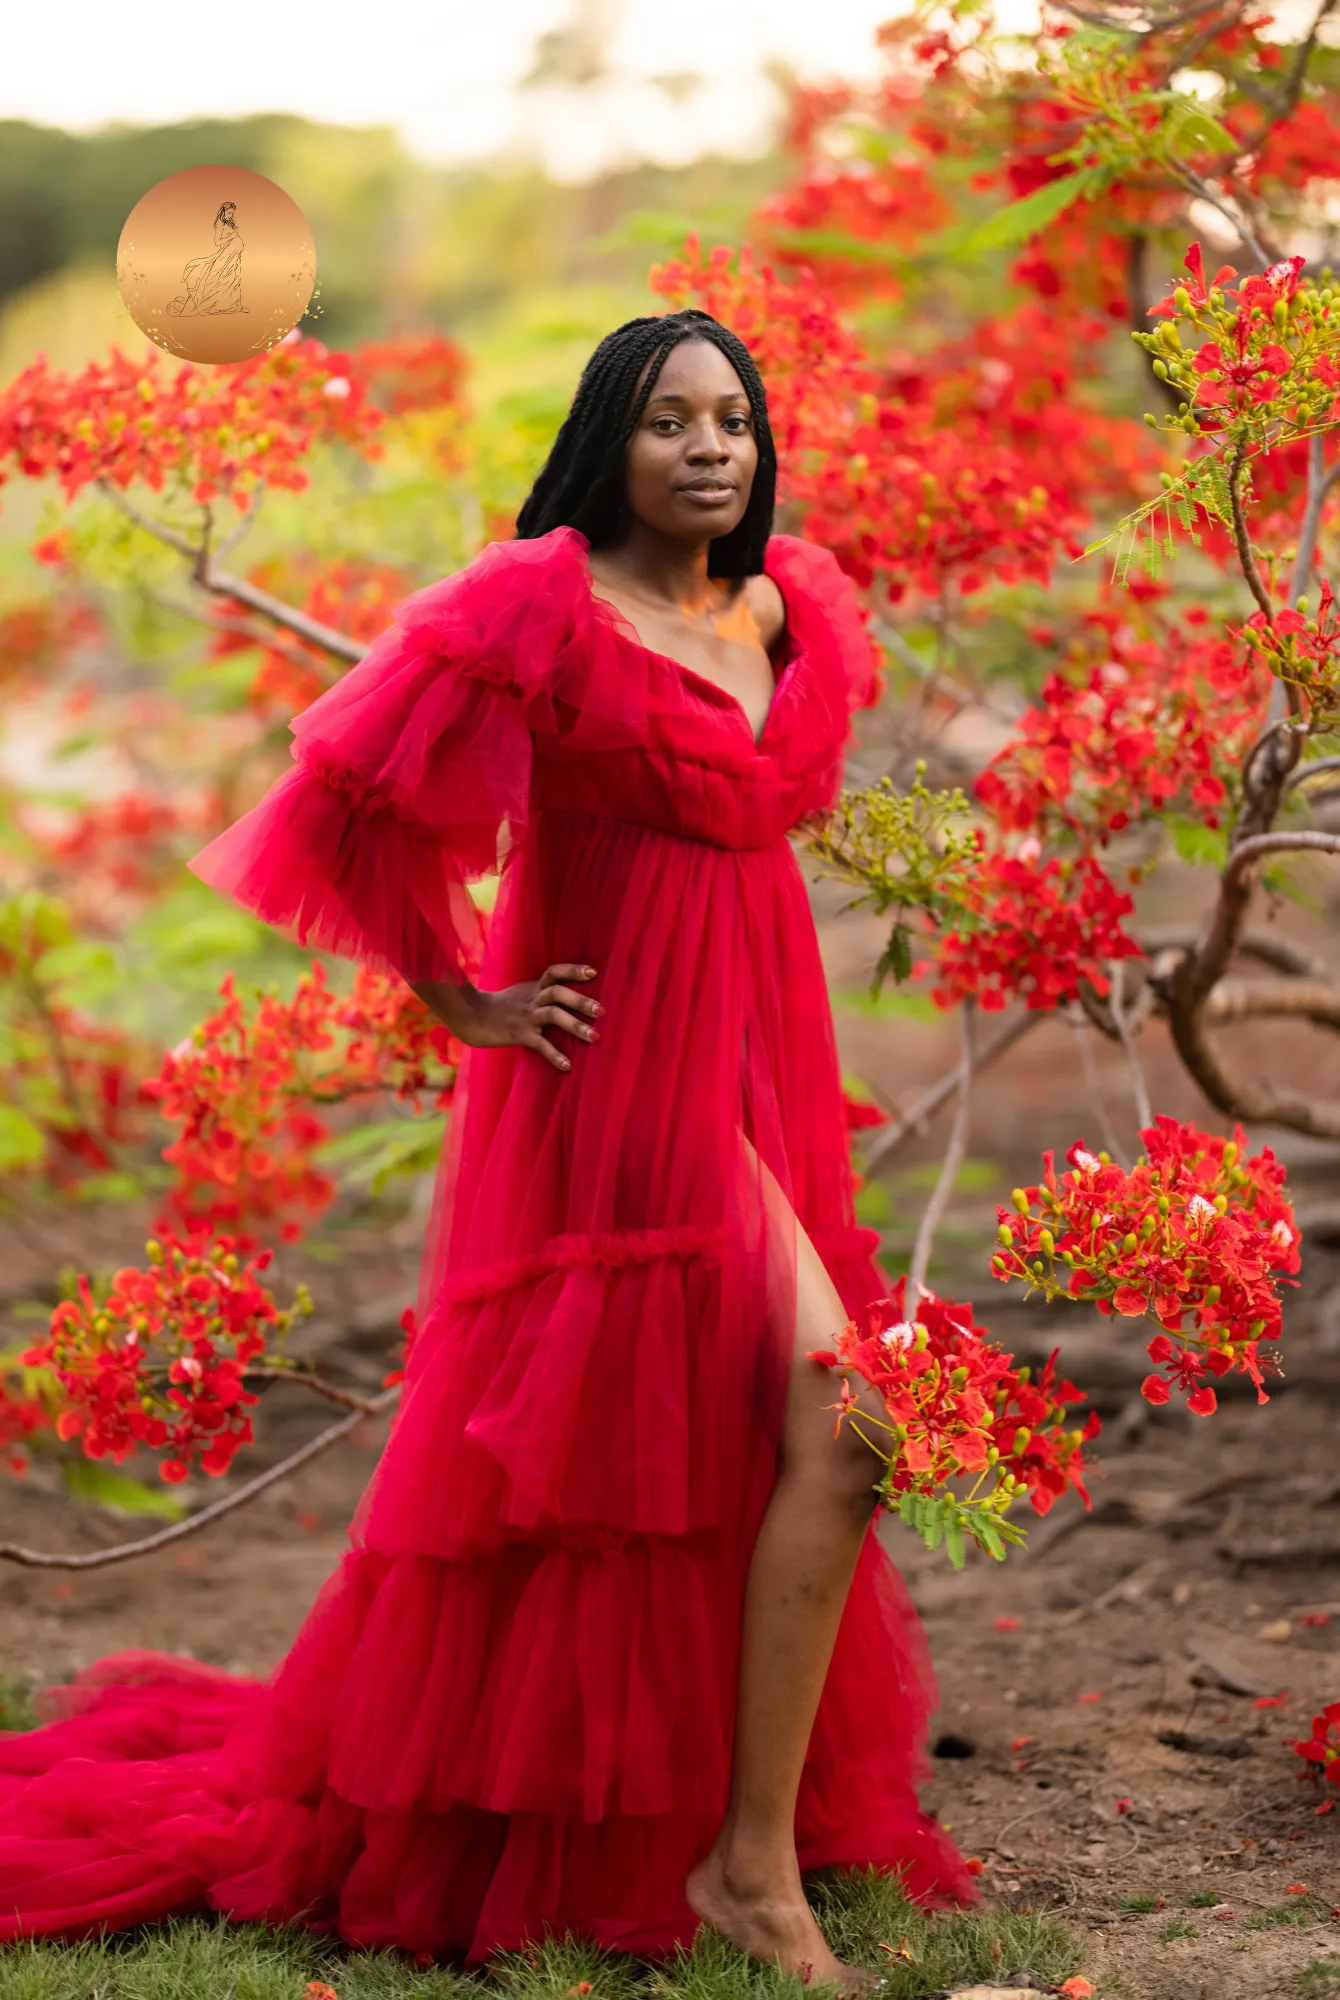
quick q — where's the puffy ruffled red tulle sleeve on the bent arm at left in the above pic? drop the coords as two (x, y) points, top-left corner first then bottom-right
(190, 538), (574, 982)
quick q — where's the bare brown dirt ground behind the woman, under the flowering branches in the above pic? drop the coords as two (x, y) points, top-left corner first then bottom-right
(0, 896), (1340, 2000)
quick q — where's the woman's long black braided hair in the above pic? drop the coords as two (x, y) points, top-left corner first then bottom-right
(516, 306), (776, 576)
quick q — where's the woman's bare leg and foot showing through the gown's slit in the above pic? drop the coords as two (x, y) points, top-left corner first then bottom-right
(686, 1168), (880, 1992)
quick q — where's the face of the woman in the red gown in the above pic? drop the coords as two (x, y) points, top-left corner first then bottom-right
(624, 340), (758, 542)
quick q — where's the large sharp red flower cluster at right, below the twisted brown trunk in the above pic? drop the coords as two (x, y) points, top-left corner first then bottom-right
(992, 1116), (1300, 1414)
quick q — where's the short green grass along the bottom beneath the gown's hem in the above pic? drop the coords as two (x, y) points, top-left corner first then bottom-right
(0, 1872), (1080, 2000)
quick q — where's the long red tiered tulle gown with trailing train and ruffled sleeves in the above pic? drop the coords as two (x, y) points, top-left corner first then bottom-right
(0, 528), (974, 1962)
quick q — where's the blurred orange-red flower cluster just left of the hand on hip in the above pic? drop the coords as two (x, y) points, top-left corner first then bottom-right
(146, 962), (458, 1248)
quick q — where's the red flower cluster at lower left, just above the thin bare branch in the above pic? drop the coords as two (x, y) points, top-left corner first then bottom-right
(22, 1236), (306, 1484)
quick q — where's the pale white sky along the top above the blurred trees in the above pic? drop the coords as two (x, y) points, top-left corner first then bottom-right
(0, 0), (968, 180)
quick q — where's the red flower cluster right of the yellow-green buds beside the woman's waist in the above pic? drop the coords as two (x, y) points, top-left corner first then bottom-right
(932, 840), (1140, 1012)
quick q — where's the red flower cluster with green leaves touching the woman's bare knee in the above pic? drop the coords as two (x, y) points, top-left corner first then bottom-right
(810, 1278), (1098, 1558)
